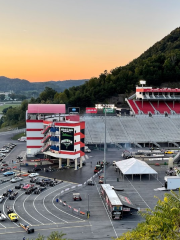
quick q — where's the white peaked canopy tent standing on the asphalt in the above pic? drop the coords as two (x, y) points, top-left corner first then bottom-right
(116, 158), (158, 180)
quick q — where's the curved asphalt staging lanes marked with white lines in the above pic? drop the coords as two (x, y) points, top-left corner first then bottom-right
(0, 174), (89, 235)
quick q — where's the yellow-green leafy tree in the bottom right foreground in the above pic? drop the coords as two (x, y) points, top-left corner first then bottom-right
(117, 189), (180, 240)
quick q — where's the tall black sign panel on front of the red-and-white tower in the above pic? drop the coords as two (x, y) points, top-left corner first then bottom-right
(60, 127), (74, 151)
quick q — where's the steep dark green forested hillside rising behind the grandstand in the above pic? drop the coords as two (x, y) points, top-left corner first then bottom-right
(32, 28), (180, 107)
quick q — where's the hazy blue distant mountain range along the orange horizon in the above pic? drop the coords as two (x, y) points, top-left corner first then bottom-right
(0, 77), (89, 93)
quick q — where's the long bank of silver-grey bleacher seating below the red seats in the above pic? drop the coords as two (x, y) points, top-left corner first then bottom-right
(83, 115), (180, 144)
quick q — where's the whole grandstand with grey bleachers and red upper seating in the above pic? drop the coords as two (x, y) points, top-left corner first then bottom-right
(83, 87), (180, 147)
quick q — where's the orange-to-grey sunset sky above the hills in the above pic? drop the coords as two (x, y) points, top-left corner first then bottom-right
(0, 0), (180, 82)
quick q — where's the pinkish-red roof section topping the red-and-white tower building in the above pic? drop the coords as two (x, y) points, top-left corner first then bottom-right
(28, 104), (66, 114)
